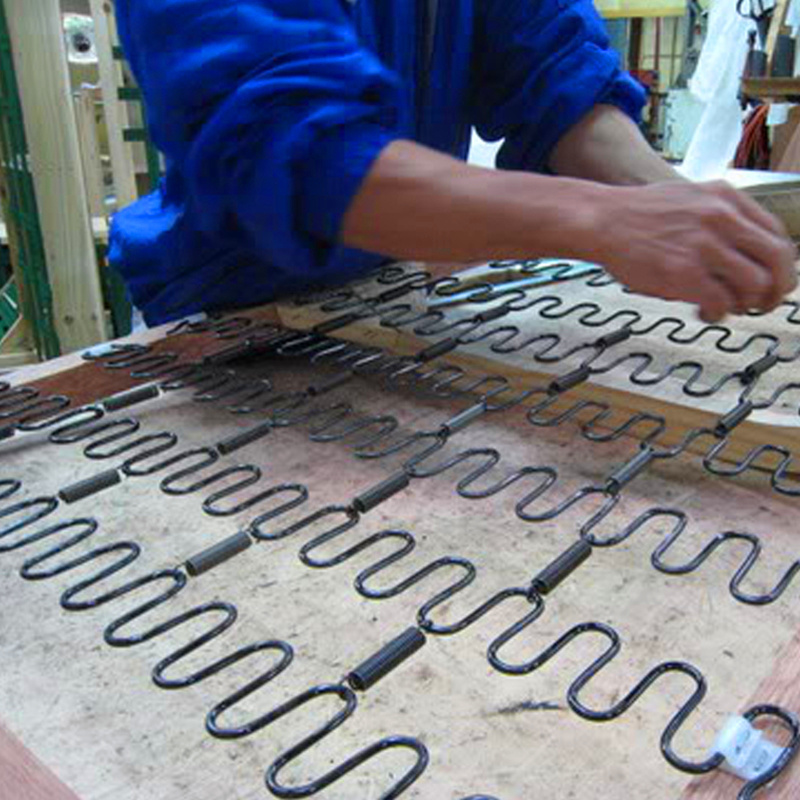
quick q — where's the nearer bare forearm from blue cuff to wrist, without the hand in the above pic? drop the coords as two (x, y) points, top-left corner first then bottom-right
(343, 141), (609, 262)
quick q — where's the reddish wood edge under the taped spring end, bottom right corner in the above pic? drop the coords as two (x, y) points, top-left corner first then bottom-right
(681, 632), (800, 800)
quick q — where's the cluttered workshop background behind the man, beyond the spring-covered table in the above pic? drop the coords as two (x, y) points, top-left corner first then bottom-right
(0, 0), (800, 369)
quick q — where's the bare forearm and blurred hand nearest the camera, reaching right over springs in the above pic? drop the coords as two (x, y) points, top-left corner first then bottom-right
(342, 141), (795, 320)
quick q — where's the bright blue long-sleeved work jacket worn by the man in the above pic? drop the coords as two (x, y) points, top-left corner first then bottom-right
(110, 0), (644, 324)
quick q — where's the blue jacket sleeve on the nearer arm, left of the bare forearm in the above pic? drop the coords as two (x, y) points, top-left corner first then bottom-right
(117, 0), (398, 276)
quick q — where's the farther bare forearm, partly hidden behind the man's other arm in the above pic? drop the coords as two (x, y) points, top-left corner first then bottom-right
(550, 105), (682, 186)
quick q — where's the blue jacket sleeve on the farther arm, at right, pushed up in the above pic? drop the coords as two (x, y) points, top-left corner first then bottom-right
(474, 0), (645, 171)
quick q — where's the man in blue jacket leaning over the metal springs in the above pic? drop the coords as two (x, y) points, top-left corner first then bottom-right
(111, 0), (796, 324)
